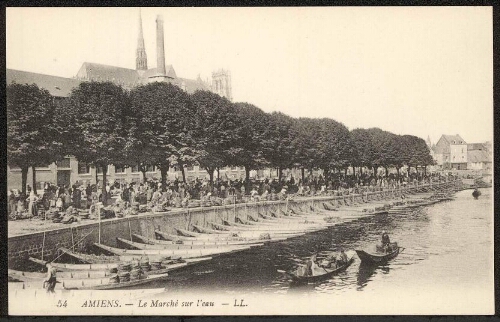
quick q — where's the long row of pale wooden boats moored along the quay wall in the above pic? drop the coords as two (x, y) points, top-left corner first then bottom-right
(8, 185), (458, 290)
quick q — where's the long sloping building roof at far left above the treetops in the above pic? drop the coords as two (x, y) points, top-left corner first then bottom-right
(6, 69), (81, 97)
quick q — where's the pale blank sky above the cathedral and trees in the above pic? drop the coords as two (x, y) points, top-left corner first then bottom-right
(7, 7), (493, 142)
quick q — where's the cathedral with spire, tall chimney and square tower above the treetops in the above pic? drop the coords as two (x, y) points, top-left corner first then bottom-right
(76, 12), (232, 101)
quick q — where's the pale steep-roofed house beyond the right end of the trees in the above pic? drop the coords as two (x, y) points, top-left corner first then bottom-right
(433, 134), (467, 170)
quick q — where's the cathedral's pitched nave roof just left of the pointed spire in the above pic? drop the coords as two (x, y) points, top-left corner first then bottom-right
(76, 62), (140, 88)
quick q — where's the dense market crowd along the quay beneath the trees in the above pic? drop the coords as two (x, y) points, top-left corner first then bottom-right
(8, 173), (458, 219)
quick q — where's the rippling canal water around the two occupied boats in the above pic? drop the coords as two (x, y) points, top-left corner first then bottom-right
(145, 189), (493, 295)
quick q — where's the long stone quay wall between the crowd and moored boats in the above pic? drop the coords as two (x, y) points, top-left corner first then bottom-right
(8, 180), (462, 270)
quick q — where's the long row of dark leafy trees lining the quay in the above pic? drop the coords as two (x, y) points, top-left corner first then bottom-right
(7, 82), (432, 199)
